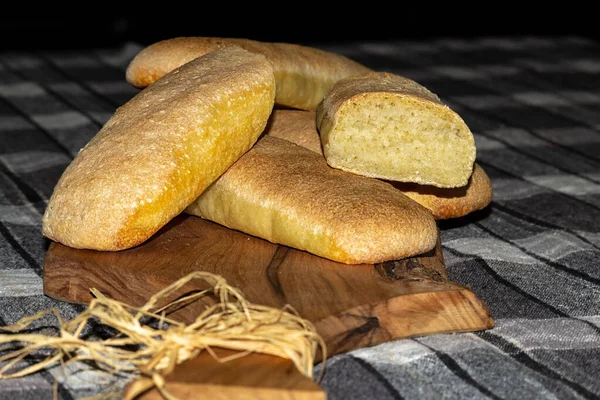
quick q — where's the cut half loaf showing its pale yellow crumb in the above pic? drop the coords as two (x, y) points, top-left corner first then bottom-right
(317, 72), (476, 188)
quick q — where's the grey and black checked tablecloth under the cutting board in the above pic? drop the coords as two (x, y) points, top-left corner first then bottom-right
(0, 36), (600, 400)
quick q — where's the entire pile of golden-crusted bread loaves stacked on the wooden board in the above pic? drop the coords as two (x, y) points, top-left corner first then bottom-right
(43, 38), (492, 264)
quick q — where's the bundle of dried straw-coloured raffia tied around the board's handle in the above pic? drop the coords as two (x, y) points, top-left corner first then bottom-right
(0, 271), (326, 399)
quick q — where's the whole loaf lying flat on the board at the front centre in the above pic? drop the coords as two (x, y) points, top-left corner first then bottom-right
(185, 136), (437, 264)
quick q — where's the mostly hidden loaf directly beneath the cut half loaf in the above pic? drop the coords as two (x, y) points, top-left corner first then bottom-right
(266, 110), (493, 220)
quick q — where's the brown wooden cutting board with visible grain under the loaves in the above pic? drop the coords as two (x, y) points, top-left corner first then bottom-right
(44, 214), (494, 398)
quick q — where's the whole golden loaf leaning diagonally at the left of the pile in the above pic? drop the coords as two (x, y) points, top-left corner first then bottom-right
(43, 47), (275, 251)
